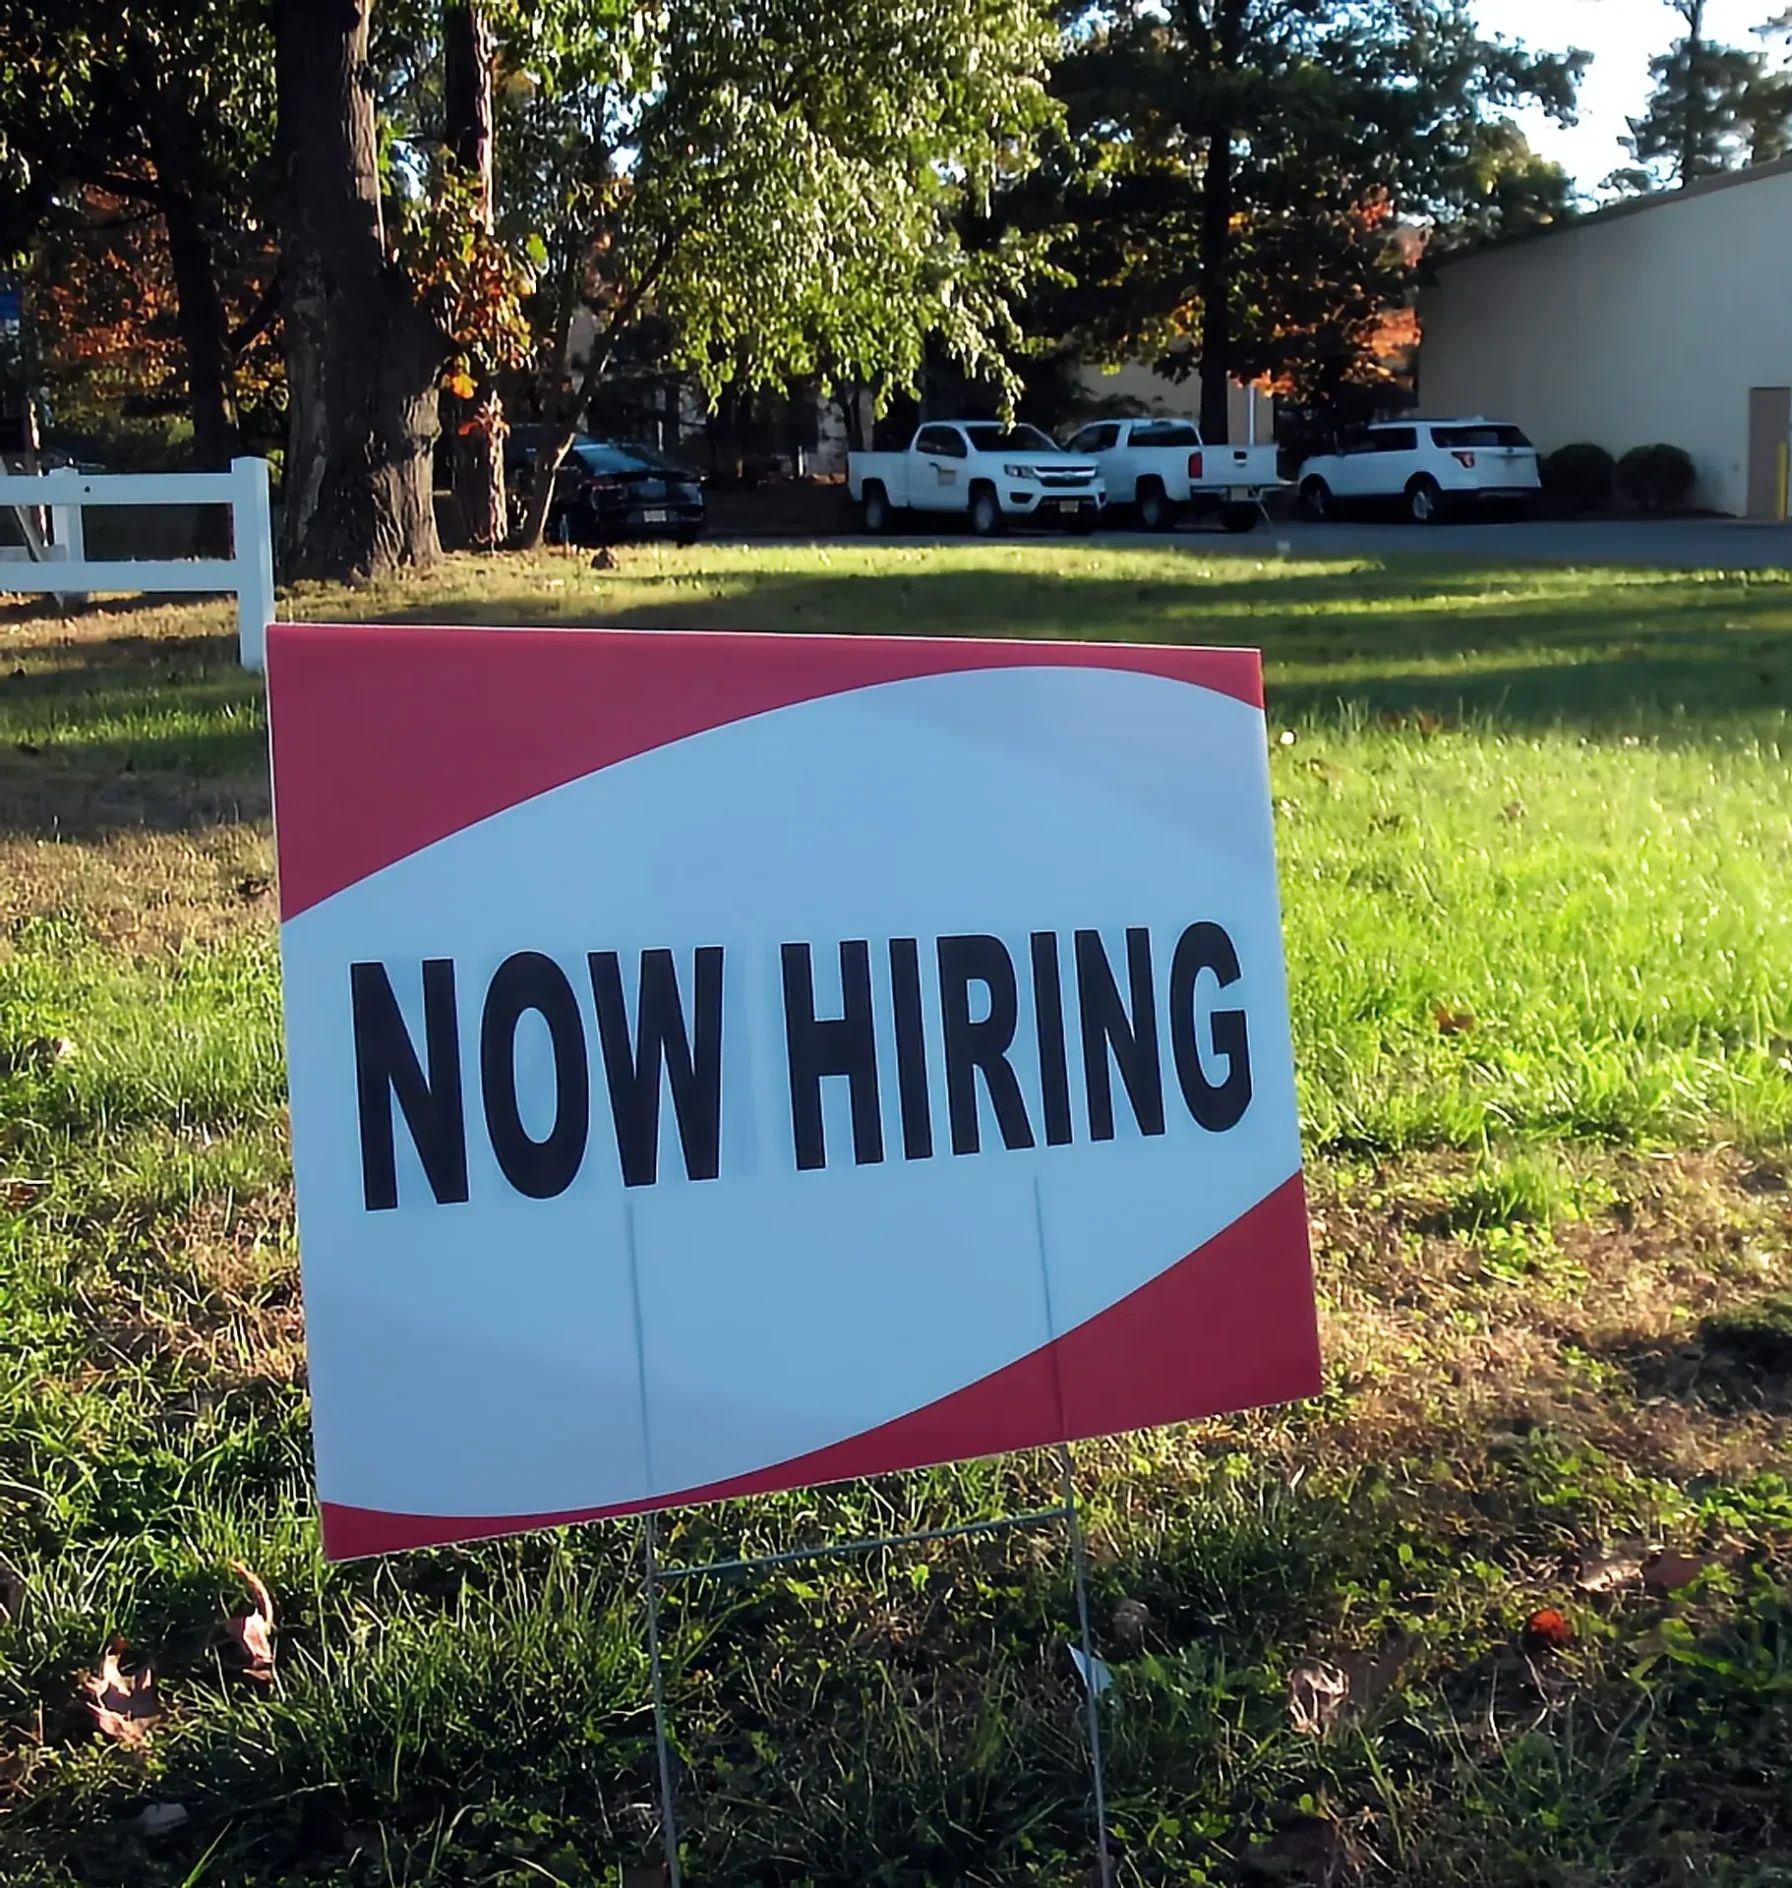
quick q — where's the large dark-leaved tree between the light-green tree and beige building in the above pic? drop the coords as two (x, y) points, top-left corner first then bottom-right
(1016, 0), (1584, 438)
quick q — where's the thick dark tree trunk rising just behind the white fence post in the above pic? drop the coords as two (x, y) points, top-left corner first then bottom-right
(274, 0), (448, 578)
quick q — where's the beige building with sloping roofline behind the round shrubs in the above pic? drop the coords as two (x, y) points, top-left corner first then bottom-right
(1418, 159), (1792, 517)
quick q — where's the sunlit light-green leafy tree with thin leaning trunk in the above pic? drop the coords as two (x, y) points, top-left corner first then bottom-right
(499, 0), (1056, 540)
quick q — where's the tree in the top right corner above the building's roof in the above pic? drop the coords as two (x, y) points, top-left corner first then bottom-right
(1607, 0), (1792, 191)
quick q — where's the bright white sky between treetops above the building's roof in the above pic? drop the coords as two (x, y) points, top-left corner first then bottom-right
(1471, 0), (1784, 194)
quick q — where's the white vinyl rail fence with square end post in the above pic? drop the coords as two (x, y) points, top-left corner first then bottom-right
(0, 459), (274, 670)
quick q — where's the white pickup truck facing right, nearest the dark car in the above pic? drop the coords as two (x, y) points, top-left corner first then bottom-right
(846, 419), (1107, 538)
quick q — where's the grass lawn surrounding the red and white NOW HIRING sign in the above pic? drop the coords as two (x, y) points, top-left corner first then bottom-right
(0, 542), (1792, 1888)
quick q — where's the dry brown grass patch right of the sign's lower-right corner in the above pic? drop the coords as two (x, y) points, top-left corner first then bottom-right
(1312, 1152), (1792, 1476)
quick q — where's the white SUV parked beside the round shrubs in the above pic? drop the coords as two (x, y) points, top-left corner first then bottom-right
(1299, 419), (1539, 525)
